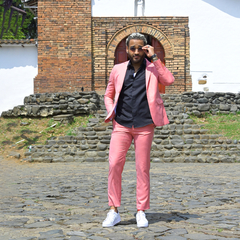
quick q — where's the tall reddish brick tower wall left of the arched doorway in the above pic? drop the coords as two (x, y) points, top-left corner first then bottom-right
(34, 0), (92, 93)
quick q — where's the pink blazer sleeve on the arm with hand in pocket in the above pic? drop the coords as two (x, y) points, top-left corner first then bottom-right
(104, 67), (115, 113)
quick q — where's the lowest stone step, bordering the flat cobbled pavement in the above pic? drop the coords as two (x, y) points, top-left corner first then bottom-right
(25, 150), (240, 163)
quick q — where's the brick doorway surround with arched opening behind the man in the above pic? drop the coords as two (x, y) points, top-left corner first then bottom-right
(92, 17), (192, 93)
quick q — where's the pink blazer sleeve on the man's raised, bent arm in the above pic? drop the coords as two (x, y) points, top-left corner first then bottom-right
(153, 59), (174, 86)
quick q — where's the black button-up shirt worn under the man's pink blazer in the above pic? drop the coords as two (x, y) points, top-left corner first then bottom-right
(115, 59), (153, 128)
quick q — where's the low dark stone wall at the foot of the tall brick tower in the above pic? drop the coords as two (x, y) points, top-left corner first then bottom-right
(1, 92), (100, 117)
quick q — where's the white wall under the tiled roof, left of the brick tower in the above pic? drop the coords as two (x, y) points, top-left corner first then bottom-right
(0, 45), (38, 114)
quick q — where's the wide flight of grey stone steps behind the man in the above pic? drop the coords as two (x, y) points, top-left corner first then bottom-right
(21, 94), (240, 165)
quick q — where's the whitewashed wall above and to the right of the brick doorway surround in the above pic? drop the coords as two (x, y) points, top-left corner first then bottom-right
(92, 0), (240, 93)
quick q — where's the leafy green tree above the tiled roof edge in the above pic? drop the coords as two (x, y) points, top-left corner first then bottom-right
(0, 0), (37, 39)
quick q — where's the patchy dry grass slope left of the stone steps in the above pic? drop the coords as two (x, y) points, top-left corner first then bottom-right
(0, 115), (93, 158)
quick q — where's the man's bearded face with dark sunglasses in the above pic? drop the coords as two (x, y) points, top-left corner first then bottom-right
(126, 39), (145, 64)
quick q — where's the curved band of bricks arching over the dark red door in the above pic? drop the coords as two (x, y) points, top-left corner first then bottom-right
(107, 24), (173, 60)
